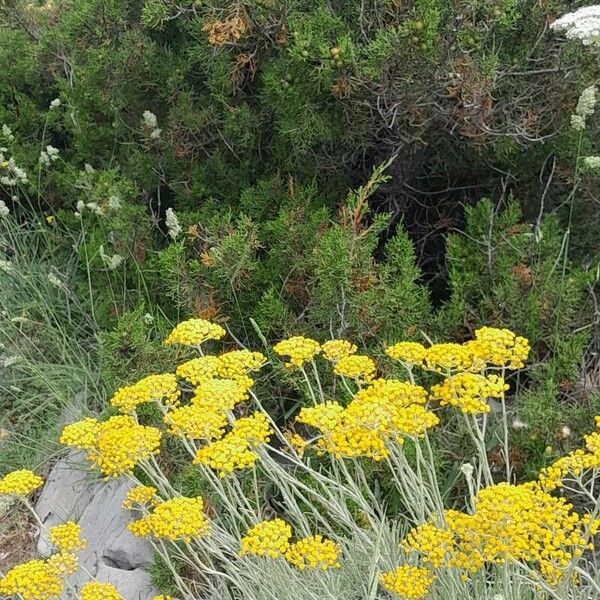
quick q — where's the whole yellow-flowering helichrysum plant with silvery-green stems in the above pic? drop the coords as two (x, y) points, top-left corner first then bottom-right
(5, 320), (600, 600)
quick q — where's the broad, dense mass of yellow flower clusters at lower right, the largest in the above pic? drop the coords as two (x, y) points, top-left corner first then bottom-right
(403, 482), (592, 585)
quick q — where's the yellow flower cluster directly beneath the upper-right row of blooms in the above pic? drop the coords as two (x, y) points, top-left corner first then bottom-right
(431, 373), (508, 414)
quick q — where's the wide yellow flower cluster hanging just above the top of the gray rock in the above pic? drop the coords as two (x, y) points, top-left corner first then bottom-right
(60, 415), (161, 477)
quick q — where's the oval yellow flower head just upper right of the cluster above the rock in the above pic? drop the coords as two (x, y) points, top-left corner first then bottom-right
(164, 402), (227, 440)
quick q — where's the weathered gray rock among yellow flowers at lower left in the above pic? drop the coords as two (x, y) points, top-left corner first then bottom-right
(36, 452), (158, 600)
